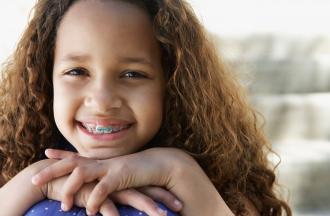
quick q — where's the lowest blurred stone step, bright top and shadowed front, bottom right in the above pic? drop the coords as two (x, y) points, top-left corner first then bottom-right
(271, 140), (330, 215)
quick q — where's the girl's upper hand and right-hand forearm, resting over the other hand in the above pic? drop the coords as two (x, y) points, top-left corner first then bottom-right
(35, 148), (233, 216)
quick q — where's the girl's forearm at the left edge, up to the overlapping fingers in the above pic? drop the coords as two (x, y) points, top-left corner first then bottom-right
(0, 161), (53, 216)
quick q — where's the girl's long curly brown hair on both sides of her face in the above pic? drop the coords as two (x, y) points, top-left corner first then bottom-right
(0, 0), (291, 216)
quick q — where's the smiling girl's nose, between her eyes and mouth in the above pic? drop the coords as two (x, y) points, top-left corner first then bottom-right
(84, 80), (123, 114)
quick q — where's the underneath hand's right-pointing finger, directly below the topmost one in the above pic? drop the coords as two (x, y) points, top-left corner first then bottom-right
(110, 189), (166, 216)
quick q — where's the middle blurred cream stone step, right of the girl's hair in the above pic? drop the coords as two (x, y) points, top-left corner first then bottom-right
(252, 93), (330, 140)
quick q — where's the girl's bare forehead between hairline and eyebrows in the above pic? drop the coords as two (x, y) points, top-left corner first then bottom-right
(55, 0), (160, 64)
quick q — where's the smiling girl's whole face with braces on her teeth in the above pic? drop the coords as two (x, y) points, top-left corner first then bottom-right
(53, 1), (164, 159)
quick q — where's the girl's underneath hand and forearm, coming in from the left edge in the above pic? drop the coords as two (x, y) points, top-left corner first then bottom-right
(0, 156), (182, 216)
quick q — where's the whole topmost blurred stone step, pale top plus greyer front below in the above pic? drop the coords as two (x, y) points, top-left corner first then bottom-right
(214, 35), (330, 94)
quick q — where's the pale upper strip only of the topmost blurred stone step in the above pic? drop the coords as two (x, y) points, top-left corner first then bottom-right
(212, 34), (330, 62)
